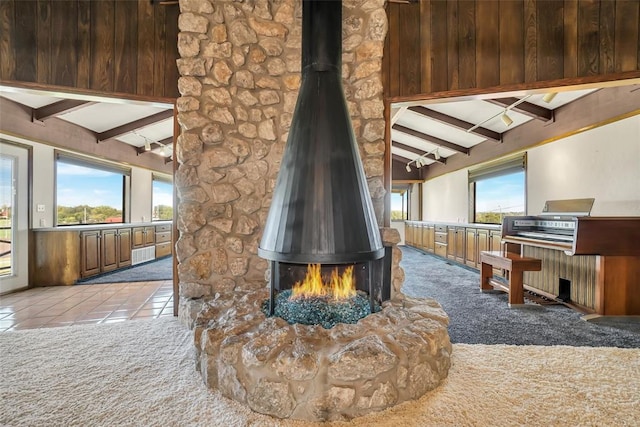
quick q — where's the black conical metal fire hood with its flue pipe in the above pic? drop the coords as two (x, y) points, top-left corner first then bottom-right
(258, 0), (384, 264)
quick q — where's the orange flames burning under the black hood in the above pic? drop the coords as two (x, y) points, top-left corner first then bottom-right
(290, 264), (356, 300)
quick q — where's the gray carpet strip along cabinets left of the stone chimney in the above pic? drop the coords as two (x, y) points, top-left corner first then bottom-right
(76, 256), (173, 285)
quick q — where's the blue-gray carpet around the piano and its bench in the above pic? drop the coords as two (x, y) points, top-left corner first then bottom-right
(400, 246), (640, 348)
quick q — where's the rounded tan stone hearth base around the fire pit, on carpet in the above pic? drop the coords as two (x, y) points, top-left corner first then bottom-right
(195, 290), (451, 421)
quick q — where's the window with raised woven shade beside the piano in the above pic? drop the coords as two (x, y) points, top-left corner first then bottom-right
(469, 154), (526, 224)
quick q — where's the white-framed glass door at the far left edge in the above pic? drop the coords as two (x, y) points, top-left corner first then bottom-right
(0, 142), (29, 294)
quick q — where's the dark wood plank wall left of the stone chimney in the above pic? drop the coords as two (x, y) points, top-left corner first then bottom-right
(0, 0), (179, 98)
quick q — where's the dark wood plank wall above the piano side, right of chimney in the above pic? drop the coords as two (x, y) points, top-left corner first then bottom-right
(383, 0), (640, 97)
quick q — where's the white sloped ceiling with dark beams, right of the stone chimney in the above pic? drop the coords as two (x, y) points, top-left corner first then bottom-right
(391, 79), (640, 192)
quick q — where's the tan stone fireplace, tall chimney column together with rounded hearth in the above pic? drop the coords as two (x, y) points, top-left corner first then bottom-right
(175, 0), (451, 421)
